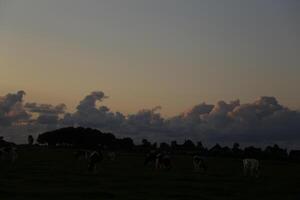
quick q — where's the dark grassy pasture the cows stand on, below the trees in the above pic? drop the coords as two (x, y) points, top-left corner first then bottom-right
(0, 147), (300, 200)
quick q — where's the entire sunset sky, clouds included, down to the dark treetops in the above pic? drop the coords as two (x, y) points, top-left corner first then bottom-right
(0, 0), (300, 148)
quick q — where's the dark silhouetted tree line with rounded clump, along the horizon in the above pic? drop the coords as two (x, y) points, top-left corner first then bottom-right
(37, 127), (300, 160)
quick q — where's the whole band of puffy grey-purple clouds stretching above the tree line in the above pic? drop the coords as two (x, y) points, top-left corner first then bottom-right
(0, 91), (300, 146)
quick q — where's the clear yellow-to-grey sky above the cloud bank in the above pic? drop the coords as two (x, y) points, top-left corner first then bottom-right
(0, 0), (300, 147)
